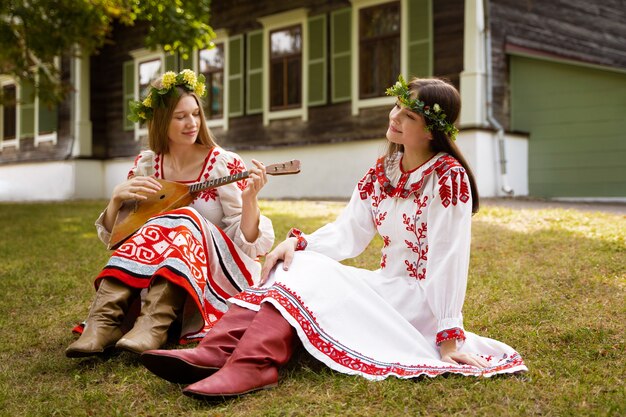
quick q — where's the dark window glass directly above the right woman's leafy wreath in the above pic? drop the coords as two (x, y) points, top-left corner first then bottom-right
(359, 2), (401, 99)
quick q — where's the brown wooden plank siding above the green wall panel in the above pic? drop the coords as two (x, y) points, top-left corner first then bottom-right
(489, 0), (626, 128)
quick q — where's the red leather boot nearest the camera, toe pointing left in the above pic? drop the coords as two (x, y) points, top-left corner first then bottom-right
(183, 303), (298, 398)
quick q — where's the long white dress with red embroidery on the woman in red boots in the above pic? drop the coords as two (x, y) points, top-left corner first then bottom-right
(231, 153), (527, 380)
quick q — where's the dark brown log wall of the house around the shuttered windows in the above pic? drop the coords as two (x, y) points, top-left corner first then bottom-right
(0, 0), (464, 163)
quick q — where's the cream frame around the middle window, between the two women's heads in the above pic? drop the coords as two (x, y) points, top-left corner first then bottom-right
(258, 8), (309, 126)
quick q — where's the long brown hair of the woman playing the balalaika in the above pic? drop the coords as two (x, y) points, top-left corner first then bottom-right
(147, 87), (217, 154)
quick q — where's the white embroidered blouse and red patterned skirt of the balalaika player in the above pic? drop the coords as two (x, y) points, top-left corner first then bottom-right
(79, 147), (274, 343)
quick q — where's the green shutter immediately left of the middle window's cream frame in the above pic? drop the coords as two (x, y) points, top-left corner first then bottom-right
(245, 30), (263, 114)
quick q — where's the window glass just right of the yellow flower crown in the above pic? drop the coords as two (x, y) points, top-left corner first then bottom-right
(198, 43), (224, 119)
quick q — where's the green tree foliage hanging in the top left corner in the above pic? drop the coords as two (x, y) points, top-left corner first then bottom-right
(0, 0), (215, 103)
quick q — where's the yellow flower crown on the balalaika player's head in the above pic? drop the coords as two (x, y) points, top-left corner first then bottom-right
(128, 69), (206, 123)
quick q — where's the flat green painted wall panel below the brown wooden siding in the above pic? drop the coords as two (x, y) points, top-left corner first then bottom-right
(510, 56), (626, 197)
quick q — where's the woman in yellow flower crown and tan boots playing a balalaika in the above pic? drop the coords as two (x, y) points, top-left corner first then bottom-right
(65, 70), (274, 358)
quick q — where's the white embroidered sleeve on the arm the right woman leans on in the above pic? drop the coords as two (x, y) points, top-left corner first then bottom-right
(420, 166), (472, 344)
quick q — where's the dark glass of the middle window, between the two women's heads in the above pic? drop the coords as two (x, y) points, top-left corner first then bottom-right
(270, 25), (302, 110)
